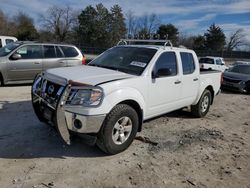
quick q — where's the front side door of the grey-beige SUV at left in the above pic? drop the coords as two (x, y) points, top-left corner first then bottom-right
(8, 45), (42, 81)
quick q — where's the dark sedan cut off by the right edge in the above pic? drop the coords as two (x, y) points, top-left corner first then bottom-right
(221, 64), (250, 94)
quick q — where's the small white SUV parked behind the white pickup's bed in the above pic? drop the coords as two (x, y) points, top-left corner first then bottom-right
(199, 56), (228, 72)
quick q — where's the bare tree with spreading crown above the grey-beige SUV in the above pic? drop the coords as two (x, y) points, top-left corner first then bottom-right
(41, 6), (77, 42)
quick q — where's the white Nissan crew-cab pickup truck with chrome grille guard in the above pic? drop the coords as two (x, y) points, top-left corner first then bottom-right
(32, 39), (221, 154)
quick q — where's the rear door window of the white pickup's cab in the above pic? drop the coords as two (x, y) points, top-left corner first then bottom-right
(180, 52), (195, 74)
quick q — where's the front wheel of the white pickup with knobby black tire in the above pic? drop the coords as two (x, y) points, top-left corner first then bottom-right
(97, 104), (139, 155)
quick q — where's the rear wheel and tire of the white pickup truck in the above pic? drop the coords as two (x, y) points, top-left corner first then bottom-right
(191, 89), (212, 118)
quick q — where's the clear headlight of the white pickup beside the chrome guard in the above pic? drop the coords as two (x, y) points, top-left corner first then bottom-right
(67, 87), (103, 107)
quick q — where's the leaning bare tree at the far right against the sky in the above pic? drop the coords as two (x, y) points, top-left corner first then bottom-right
(227, 29), (246, 51)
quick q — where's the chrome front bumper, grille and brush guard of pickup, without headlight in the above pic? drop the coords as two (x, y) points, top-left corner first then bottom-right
(32, 76), (106, 144)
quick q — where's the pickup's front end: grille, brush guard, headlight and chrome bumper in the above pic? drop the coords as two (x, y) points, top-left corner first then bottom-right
(32, 73), (106, 144)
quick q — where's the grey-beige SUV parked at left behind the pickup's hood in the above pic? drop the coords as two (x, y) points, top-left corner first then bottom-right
(0, 42), (86, 85)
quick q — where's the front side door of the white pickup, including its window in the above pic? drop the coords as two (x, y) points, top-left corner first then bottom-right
(148, 52), (182, 117)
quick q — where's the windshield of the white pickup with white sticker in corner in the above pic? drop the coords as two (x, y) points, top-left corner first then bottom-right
(88, 47), (157, 75)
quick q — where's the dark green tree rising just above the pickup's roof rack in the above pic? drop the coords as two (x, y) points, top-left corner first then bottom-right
(157, 24), (179, 45)
